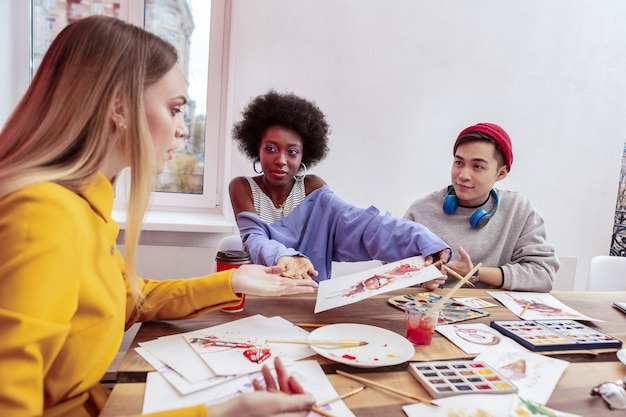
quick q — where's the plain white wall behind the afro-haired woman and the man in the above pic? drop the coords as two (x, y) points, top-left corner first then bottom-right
(0, 0), (626, 289)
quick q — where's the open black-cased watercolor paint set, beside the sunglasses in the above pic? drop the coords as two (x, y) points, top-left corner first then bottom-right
(491, 320), (622, 352)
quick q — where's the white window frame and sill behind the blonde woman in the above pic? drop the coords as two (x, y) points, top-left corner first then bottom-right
(7, 0), (236, 234)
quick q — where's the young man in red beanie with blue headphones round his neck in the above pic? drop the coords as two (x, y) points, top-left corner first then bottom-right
(404, 123), (560, 292)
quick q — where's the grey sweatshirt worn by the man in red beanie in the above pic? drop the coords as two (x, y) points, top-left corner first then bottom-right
(404, 187), (560, 292)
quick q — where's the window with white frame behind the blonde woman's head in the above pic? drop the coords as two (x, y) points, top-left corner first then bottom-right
(31, 0), (230, 219)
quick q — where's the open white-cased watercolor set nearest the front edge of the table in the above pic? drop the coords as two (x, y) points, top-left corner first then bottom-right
(409, 360), (517, 398)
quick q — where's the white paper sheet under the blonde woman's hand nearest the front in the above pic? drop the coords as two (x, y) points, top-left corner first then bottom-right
(143, 360), (362, 417)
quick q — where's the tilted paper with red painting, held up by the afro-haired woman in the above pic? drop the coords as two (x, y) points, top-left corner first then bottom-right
(315, 256), (442, 313)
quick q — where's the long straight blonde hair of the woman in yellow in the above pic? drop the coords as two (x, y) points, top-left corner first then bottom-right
(0, 16), (178, 300)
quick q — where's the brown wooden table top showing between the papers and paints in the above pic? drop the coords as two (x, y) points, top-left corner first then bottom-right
(106, 288), (626, 417)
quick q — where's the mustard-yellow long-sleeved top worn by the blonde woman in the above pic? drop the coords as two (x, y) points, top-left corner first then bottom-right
(0, 174), (240, 417)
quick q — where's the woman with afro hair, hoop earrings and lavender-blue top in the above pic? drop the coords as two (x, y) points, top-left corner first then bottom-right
(229, 91), (450, 281)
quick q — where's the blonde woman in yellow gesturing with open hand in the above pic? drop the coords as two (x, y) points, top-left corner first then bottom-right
(0, 16), (316, 417)
